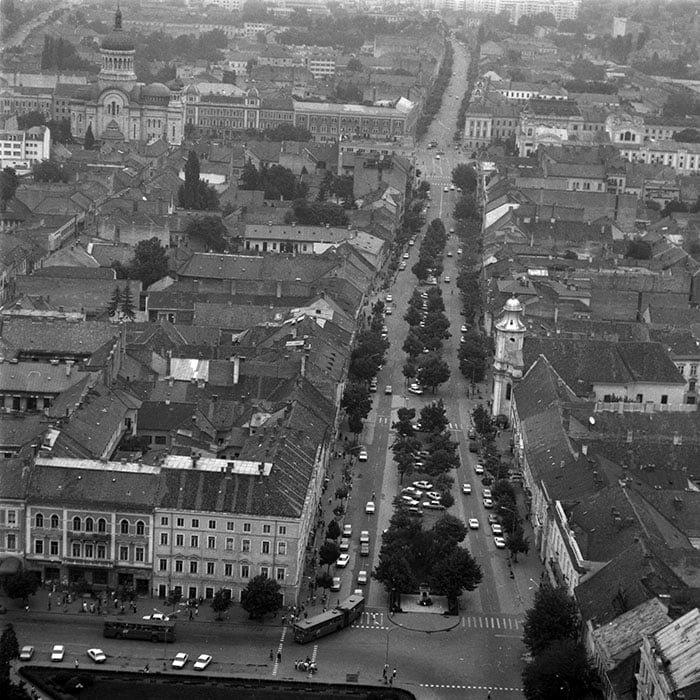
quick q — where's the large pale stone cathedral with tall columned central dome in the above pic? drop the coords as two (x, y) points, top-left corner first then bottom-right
(70, 8), (185, 145)
